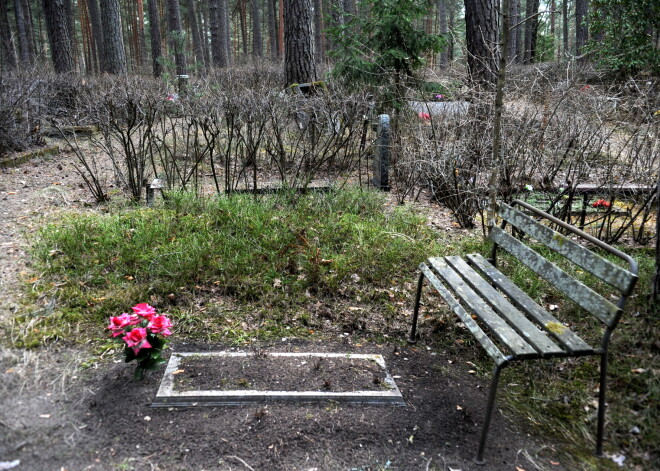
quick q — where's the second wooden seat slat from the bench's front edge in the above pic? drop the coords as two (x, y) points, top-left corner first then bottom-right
(428, 257), (539, 358)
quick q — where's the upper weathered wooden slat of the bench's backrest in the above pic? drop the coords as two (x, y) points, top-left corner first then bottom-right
(499, 203), (637, 293)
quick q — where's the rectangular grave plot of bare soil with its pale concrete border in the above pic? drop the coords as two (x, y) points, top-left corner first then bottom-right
(152, 352), (405, 407)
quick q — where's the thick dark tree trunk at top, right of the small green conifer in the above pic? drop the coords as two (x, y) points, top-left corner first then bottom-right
(465, 0), (499, 89)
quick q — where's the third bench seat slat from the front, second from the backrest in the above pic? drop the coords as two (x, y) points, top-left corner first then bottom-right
(445, 256), (565, 356)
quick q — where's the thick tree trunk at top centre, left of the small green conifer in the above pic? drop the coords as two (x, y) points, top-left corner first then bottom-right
(284, 0), (316, 86)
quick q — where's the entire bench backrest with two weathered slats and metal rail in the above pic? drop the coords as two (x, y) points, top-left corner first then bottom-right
(490, 200), (637, 329)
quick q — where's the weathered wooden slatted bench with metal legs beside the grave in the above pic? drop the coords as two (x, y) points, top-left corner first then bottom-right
(410, 200), (637, 463)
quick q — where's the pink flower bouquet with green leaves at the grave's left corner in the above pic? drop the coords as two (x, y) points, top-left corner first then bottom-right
(107, 303), (172, 380)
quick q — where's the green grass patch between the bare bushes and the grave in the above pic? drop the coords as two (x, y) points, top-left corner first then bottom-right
(12, 189), (441, 346)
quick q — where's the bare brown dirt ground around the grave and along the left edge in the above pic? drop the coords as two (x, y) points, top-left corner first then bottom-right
(0, 149), (564, 471)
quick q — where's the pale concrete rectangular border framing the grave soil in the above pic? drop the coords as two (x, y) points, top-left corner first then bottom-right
(151, 351), (405, 407)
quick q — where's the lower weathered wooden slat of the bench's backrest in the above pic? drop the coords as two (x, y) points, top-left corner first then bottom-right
(490, 227), (619, 326)
